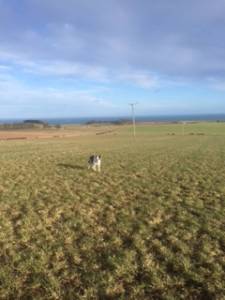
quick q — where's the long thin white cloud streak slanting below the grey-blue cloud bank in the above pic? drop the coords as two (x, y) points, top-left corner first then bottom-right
(0, 46), (161, 89)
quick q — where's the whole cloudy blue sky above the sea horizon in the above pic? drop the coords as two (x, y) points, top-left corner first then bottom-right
(0, 0), (225, 118)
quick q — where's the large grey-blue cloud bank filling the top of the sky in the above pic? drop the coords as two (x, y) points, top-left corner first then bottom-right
(0, 0), (225, 81)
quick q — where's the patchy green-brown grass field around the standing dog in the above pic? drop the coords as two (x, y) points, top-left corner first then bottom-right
(0, 123), (225, 300)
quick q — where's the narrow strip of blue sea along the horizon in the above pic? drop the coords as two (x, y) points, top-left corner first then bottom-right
(0, 114), (225, 125)
